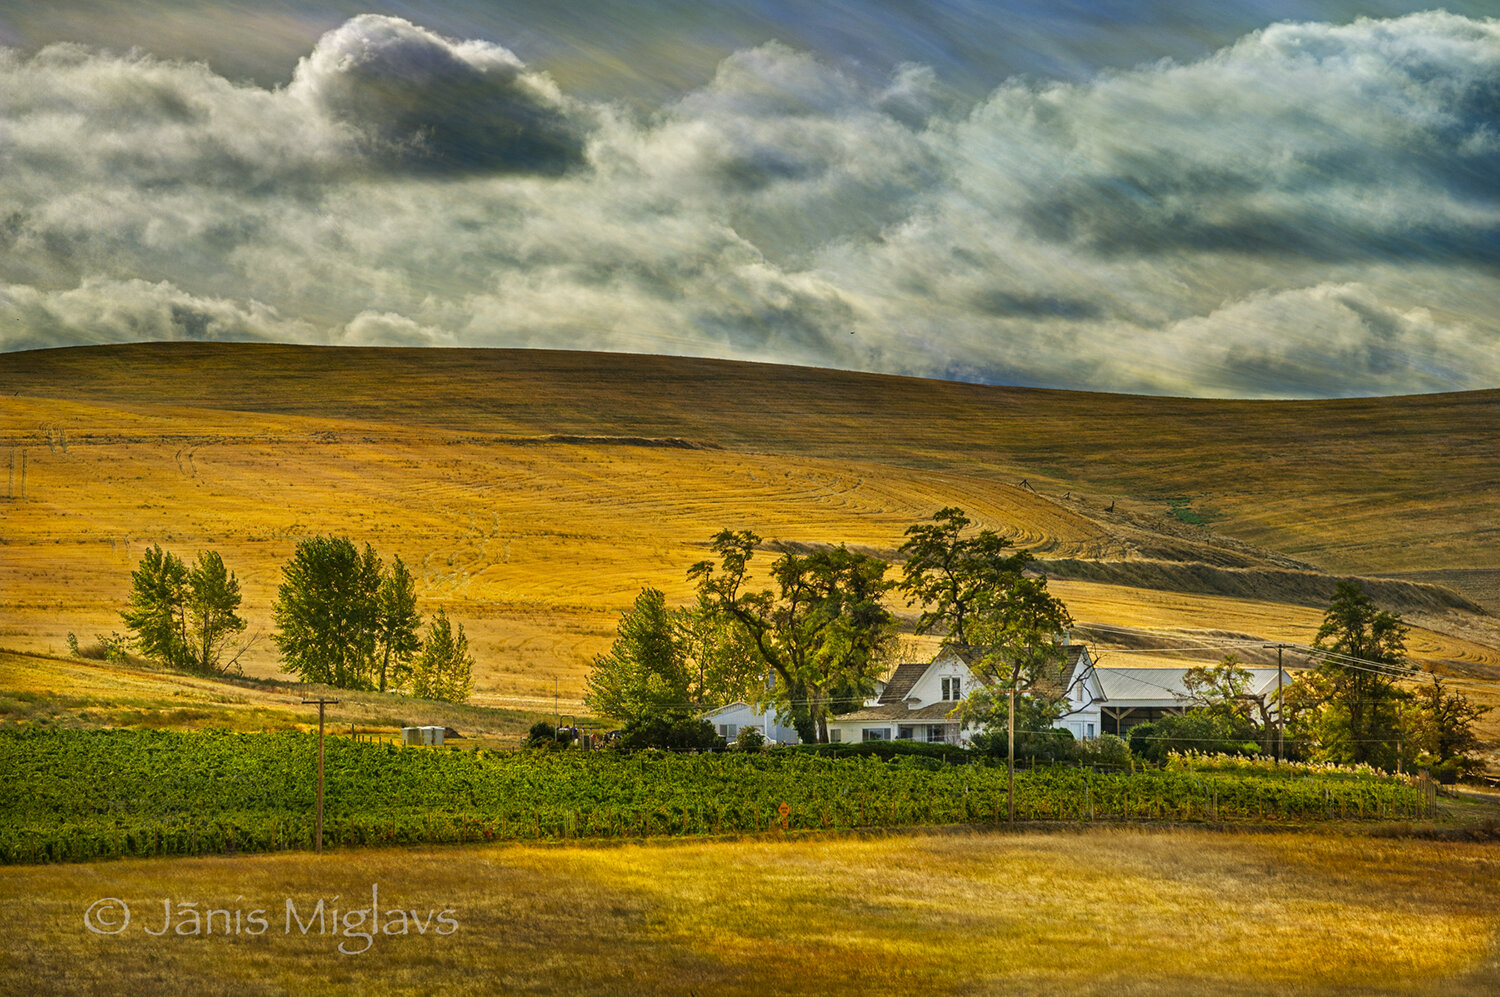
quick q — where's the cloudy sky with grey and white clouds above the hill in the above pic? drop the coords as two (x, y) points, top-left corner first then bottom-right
(0, 0), (1500, 397)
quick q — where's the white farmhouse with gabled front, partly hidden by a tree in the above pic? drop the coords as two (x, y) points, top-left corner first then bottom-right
(828, 645), (1104, 745)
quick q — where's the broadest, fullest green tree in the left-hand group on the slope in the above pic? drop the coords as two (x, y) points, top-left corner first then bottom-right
(272, 537), (381, 690)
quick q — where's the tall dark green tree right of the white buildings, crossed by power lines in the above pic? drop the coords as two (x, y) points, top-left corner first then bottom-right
(1313, 582), (1410, 768)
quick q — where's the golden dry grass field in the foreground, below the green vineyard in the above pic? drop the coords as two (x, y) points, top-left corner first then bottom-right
(0, 829), (1500, 996)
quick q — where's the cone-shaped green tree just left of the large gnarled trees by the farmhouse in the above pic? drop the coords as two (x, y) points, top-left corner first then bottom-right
(584, 588), (695, 724)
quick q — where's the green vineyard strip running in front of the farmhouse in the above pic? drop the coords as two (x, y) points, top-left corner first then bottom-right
(0, 730), (1424, 864)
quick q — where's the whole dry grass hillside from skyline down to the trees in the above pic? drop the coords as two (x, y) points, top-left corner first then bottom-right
(0, 345), (1500, 719)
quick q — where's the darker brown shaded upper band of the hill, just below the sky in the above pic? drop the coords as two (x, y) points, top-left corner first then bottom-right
(0, 343), (1500, 571)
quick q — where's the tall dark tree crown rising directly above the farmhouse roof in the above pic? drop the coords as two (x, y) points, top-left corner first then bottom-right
(897, 507), (1032, 645)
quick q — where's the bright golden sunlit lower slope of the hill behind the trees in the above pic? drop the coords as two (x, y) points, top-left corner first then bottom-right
(0, 399), (1500, 711)
